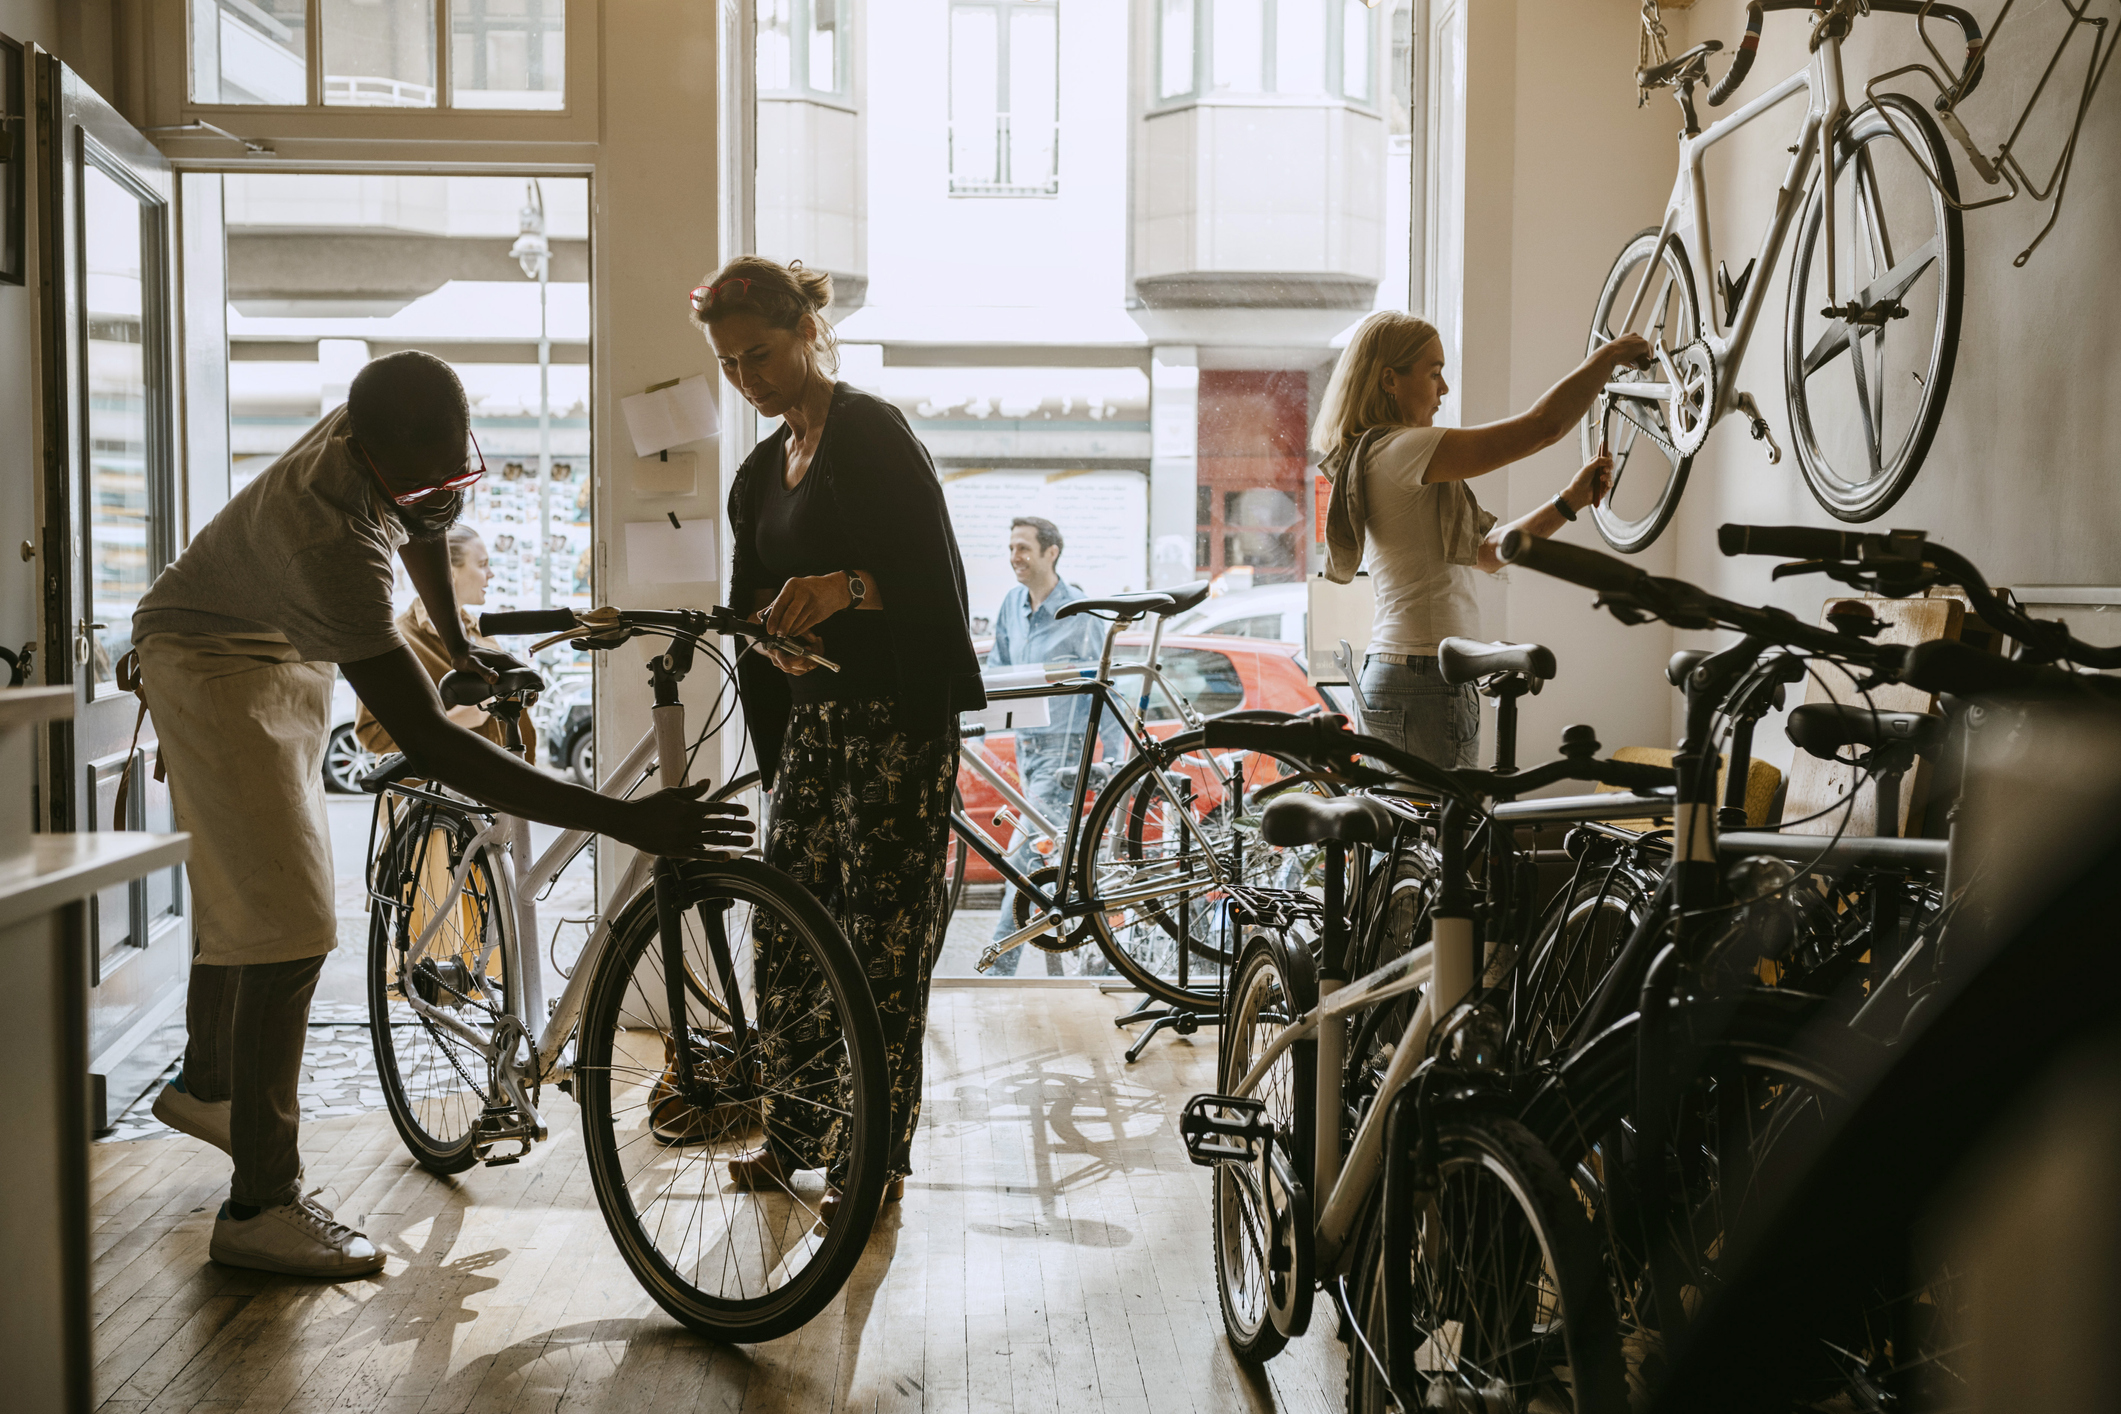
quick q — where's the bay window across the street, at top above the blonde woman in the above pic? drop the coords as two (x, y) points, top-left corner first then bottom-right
(1156, 0), (1377, 104)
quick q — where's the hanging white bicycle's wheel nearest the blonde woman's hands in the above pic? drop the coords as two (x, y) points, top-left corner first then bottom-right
(1582, 227), (1714, 555)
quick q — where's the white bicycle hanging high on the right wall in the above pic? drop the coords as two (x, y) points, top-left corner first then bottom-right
(1584, 0), (2113, 553)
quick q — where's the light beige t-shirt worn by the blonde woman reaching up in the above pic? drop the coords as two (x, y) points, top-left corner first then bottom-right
(1362, 426), (1480, 657)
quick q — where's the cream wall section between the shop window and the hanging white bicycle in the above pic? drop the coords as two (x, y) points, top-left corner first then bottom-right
(1453, 0), (1676, 761)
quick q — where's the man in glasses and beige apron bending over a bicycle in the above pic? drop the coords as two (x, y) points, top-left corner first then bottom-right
(134, 352), (749, 1280)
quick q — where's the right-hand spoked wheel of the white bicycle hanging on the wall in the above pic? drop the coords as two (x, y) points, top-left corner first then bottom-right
(1784, 95), (1966, 522)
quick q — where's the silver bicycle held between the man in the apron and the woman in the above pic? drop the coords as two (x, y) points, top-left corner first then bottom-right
(363, 608), (891, 1342)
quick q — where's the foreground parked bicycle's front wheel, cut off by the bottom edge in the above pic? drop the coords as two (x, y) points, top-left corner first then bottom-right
(1349, 1115), (1627, 1414)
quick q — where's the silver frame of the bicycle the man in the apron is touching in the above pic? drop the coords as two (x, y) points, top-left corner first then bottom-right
(373, 704), (689, 1141)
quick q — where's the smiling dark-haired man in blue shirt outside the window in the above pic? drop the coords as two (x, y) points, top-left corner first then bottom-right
(986, 515), (1126, 977)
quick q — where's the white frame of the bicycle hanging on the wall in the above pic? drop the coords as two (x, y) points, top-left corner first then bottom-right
(1606, 22), (1874, 426)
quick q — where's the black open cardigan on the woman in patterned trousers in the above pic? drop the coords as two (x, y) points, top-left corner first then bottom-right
(730, 384), (986, 786)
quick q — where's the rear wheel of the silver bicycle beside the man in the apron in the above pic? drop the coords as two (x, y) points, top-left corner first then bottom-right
(369, 797), (513, 1174)
